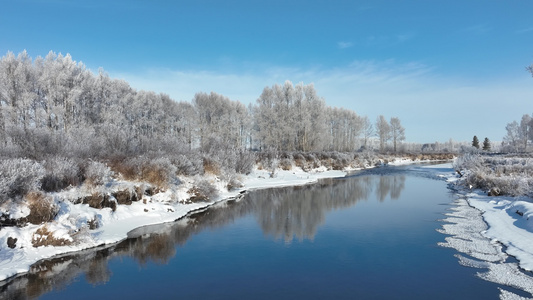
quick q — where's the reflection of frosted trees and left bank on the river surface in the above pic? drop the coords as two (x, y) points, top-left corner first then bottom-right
(0, 174), (405, 299)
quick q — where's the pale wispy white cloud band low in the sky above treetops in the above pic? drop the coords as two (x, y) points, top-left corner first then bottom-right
(110, 59), (533, 142)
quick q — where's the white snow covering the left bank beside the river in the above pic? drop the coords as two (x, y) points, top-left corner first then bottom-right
(0, 168), (346, 280)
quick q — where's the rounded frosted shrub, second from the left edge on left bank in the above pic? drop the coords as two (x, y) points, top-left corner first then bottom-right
(41, 157), (81, 192)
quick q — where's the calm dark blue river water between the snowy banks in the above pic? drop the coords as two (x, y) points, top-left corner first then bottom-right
(0, 167), (524, 299)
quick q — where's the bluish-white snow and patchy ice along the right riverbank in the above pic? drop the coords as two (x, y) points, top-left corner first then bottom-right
(440, 165), (533, 299)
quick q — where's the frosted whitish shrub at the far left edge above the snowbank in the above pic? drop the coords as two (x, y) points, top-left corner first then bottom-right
(0, 158), (45, 203)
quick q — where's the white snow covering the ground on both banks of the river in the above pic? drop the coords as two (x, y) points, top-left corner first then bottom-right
(0, 160), (533, 299)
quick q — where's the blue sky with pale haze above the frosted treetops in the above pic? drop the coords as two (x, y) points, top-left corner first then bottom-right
(0, 0), (533, 142)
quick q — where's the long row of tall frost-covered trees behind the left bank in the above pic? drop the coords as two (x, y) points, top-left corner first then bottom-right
(0, 51), (405, 160)
